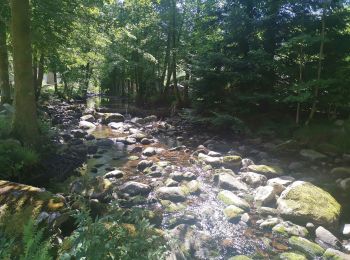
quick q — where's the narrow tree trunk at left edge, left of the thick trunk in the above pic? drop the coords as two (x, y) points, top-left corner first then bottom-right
(0, 19), (11, 103)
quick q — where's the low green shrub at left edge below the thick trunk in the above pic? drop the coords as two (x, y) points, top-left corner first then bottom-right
(0, 139), (39, 180)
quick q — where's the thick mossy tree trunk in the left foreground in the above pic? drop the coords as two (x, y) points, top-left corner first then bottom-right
(11, 0), (39, 146)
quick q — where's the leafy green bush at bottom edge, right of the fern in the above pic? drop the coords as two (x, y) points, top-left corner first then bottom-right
(59, 205), (165, 260)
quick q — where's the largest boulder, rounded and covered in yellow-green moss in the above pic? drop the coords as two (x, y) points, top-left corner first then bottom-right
(277, 181), (341, 226)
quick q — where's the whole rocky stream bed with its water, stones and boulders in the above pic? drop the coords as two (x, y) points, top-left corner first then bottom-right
(7, 97), (350, 260)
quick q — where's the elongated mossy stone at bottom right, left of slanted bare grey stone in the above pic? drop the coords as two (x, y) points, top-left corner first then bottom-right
(288, 236), (325, 259)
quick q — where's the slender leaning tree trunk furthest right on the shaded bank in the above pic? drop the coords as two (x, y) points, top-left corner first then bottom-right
(305, 6), (326, 125)
